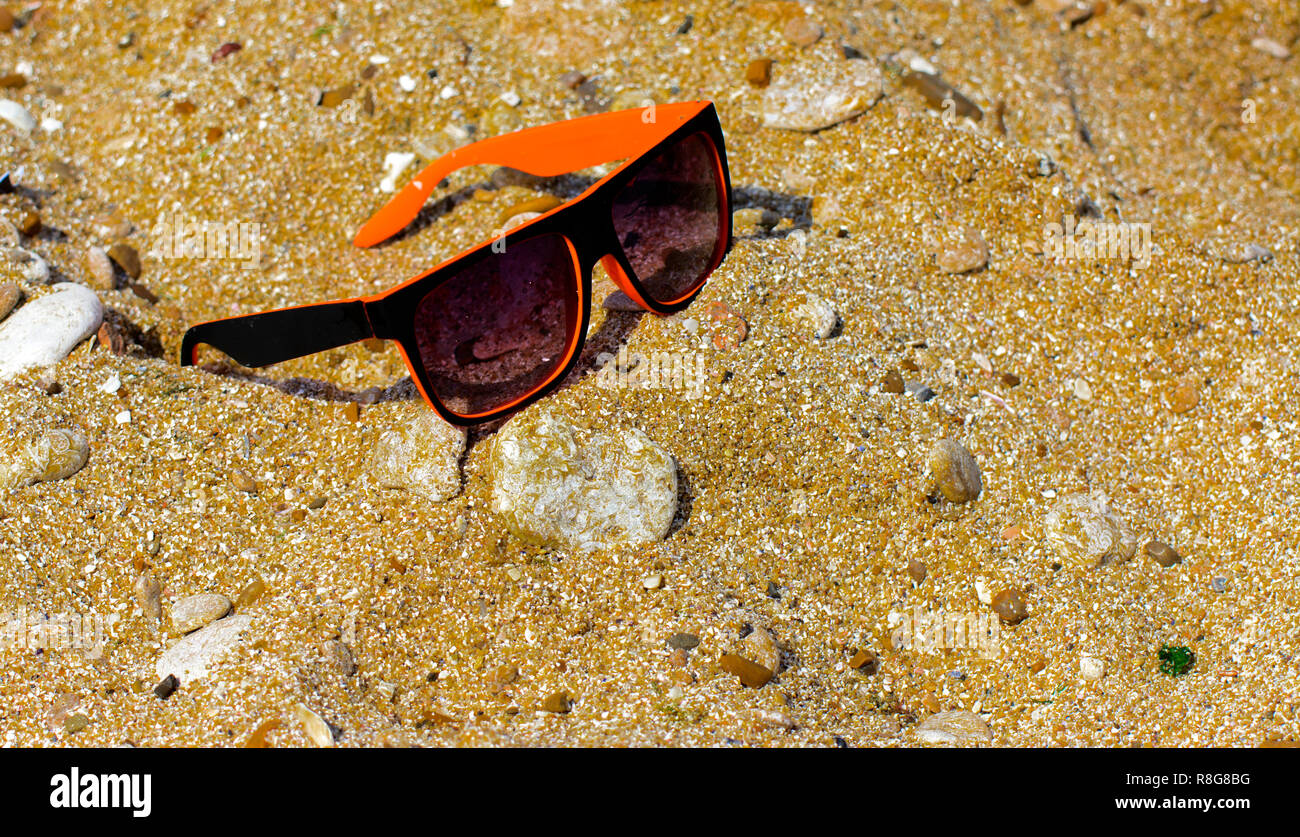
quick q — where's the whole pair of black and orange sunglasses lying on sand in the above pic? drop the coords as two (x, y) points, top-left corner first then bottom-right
(181, 101), (731, 425)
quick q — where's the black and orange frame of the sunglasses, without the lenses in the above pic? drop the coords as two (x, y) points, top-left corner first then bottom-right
(181, 101), (732, 425)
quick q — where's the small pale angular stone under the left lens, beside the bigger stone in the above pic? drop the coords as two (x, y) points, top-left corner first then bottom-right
(371, 406), (465, 502)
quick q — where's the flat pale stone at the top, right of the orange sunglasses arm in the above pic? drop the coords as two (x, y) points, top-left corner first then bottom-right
(762, 48), (884, 131)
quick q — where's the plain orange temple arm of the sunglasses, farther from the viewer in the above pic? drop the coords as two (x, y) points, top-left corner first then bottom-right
(352, 101), (711, 247)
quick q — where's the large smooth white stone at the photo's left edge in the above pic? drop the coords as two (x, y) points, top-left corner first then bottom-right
(0, 283), (104, 381)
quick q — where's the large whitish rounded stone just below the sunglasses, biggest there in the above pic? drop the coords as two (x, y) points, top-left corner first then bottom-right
(489, 407), (677, 551)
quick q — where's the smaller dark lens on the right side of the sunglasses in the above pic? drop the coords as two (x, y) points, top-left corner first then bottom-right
(614, 134), (723, 304)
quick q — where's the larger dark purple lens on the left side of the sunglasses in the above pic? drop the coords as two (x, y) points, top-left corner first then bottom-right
(415, 234), (582, 416)
